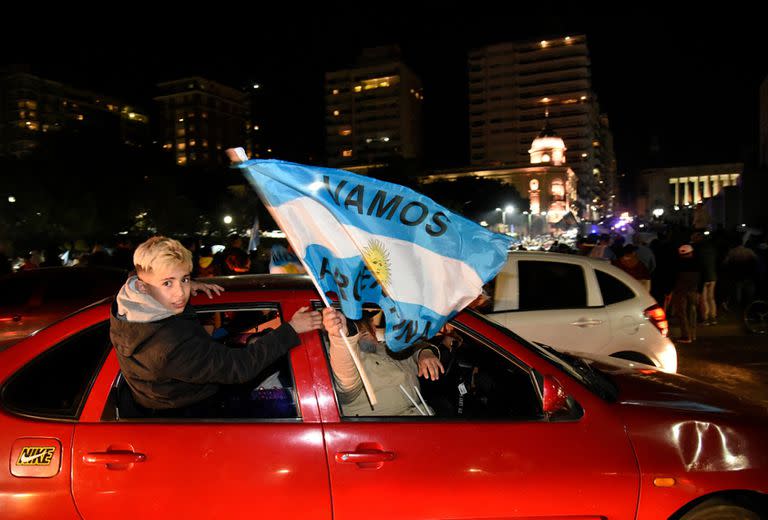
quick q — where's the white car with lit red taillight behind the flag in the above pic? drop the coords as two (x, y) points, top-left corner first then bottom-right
(486, 251), (677, 372)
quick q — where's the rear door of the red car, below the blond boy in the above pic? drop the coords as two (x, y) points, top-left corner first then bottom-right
(72, 309), (331, 520)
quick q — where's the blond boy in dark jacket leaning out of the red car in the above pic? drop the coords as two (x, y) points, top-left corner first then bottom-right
(109, 236), (321, 417)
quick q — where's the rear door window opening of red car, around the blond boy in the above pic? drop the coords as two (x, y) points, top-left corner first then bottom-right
(102, 306), (300, 421)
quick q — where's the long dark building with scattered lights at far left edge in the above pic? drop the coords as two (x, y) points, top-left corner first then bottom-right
(0, 71), (149, 157)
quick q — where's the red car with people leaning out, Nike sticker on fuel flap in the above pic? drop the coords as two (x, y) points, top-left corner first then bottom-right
(0, 275), (768, 520)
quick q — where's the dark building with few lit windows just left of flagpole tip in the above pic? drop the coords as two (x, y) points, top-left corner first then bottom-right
(155, 77), (249, 166)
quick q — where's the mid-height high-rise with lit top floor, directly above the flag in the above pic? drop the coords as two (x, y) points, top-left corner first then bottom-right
(325, 47), (424, 167)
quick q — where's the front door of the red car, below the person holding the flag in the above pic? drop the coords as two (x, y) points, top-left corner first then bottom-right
(316, 312), (639, 520)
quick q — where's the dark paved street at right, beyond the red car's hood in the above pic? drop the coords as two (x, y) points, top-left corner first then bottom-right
(670, 313), (768, 410)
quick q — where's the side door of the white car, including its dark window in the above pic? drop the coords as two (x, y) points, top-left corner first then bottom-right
(489, 256), (611, 352)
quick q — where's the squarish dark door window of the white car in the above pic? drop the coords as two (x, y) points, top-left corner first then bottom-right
(517, 260), (587, 311)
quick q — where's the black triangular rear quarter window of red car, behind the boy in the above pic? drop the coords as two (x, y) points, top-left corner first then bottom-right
(1, 321), (110, 419)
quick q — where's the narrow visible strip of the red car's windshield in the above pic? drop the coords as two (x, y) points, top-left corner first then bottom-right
(468, 311), (619, 402)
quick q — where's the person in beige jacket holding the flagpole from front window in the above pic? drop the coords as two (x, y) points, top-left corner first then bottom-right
(323, 307), (443, 416)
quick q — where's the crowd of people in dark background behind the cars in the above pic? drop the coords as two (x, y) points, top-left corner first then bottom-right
(6, 220), (768, 348)
